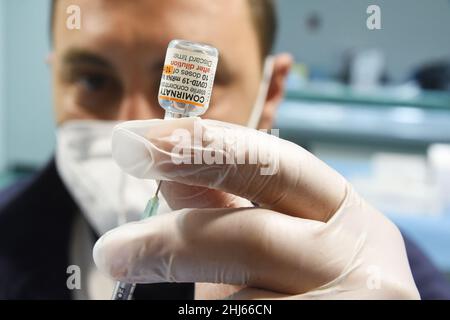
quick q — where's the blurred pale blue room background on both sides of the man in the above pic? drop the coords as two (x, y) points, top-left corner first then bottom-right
(0, 0), (450, 275)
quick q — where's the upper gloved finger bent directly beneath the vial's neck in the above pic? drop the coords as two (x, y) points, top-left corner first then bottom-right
(113, 118), (346, 221)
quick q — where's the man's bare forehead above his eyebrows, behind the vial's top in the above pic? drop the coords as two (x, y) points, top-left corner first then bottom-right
(54, 0), (257, 58)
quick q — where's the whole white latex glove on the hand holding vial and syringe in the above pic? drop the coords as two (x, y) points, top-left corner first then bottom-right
(94, 118), (419, 299)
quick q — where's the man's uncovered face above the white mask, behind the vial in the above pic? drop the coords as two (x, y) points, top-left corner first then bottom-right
(52, 0), (274, 125)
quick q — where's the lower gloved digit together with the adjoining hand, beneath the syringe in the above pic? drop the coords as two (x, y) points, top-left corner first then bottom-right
(94, 184), (419, 299)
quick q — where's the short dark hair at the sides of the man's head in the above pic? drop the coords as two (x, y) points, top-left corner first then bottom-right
(50, 0), (277, 57)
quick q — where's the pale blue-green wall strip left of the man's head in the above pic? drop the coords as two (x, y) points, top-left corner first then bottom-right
(0, 0), (54, 169)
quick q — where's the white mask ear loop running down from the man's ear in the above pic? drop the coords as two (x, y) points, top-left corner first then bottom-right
(247, 56), (275, 129)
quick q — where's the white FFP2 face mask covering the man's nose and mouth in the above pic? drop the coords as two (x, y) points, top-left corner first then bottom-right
(56, 120), (169, 235)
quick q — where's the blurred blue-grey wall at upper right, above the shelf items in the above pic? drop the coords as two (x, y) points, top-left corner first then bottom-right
(277, 0), (450, 80)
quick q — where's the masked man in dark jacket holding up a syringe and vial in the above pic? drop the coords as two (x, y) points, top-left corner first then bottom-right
(0, 0), (447, 299)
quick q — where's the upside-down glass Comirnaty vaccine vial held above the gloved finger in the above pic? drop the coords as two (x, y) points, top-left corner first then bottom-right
(158, 40), (219, 118)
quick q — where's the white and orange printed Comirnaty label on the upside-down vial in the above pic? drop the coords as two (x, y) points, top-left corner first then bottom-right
(159, 48), (218, 108)
